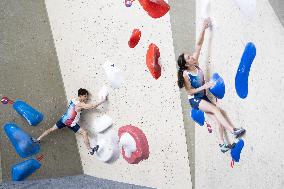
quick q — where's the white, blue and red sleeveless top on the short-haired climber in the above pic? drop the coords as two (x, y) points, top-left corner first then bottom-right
(61, 99), (81, 127)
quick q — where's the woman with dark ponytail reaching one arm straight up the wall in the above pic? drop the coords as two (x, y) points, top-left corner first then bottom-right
(177, 18), (245, 153)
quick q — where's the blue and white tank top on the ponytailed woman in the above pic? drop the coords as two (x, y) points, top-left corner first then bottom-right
(185, 67), (205, 99)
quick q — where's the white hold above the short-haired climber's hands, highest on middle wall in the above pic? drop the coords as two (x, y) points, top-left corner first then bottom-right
(103, 61), (124, 88)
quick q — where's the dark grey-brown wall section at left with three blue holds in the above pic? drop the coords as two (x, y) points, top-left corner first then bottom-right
(0, 0), (82, 182)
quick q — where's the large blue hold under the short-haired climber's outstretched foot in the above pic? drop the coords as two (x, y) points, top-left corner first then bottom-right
(4, 123), (40, 158)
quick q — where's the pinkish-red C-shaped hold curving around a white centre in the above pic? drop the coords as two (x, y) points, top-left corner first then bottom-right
(118, 125), (150, 164)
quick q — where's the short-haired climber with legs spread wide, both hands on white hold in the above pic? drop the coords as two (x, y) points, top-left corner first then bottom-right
(33, 88), (107, 155)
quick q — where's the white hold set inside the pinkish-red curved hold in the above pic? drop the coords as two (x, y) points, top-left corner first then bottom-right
(119, 133), (137, 158)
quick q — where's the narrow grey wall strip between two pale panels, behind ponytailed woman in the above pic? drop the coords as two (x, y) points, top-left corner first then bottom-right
(169, 0), (196, 189)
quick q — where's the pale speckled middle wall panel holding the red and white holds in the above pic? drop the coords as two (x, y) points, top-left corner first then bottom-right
(46, 0), (191, 188)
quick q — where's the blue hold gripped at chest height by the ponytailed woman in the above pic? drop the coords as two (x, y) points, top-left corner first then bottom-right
(209, 73), (225, 99)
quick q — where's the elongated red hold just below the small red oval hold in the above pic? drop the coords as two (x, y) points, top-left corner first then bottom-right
(146, 43), (161, 79)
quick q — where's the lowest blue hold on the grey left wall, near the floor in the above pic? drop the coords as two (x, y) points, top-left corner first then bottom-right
(11, 159), (41, 181)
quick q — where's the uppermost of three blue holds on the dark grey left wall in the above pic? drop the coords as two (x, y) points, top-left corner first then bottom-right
(13, 100), (43, 126)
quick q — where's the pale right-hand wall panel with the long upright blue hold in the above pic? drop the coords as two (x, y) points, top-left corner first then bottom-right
(195, 0), (284, 189)
